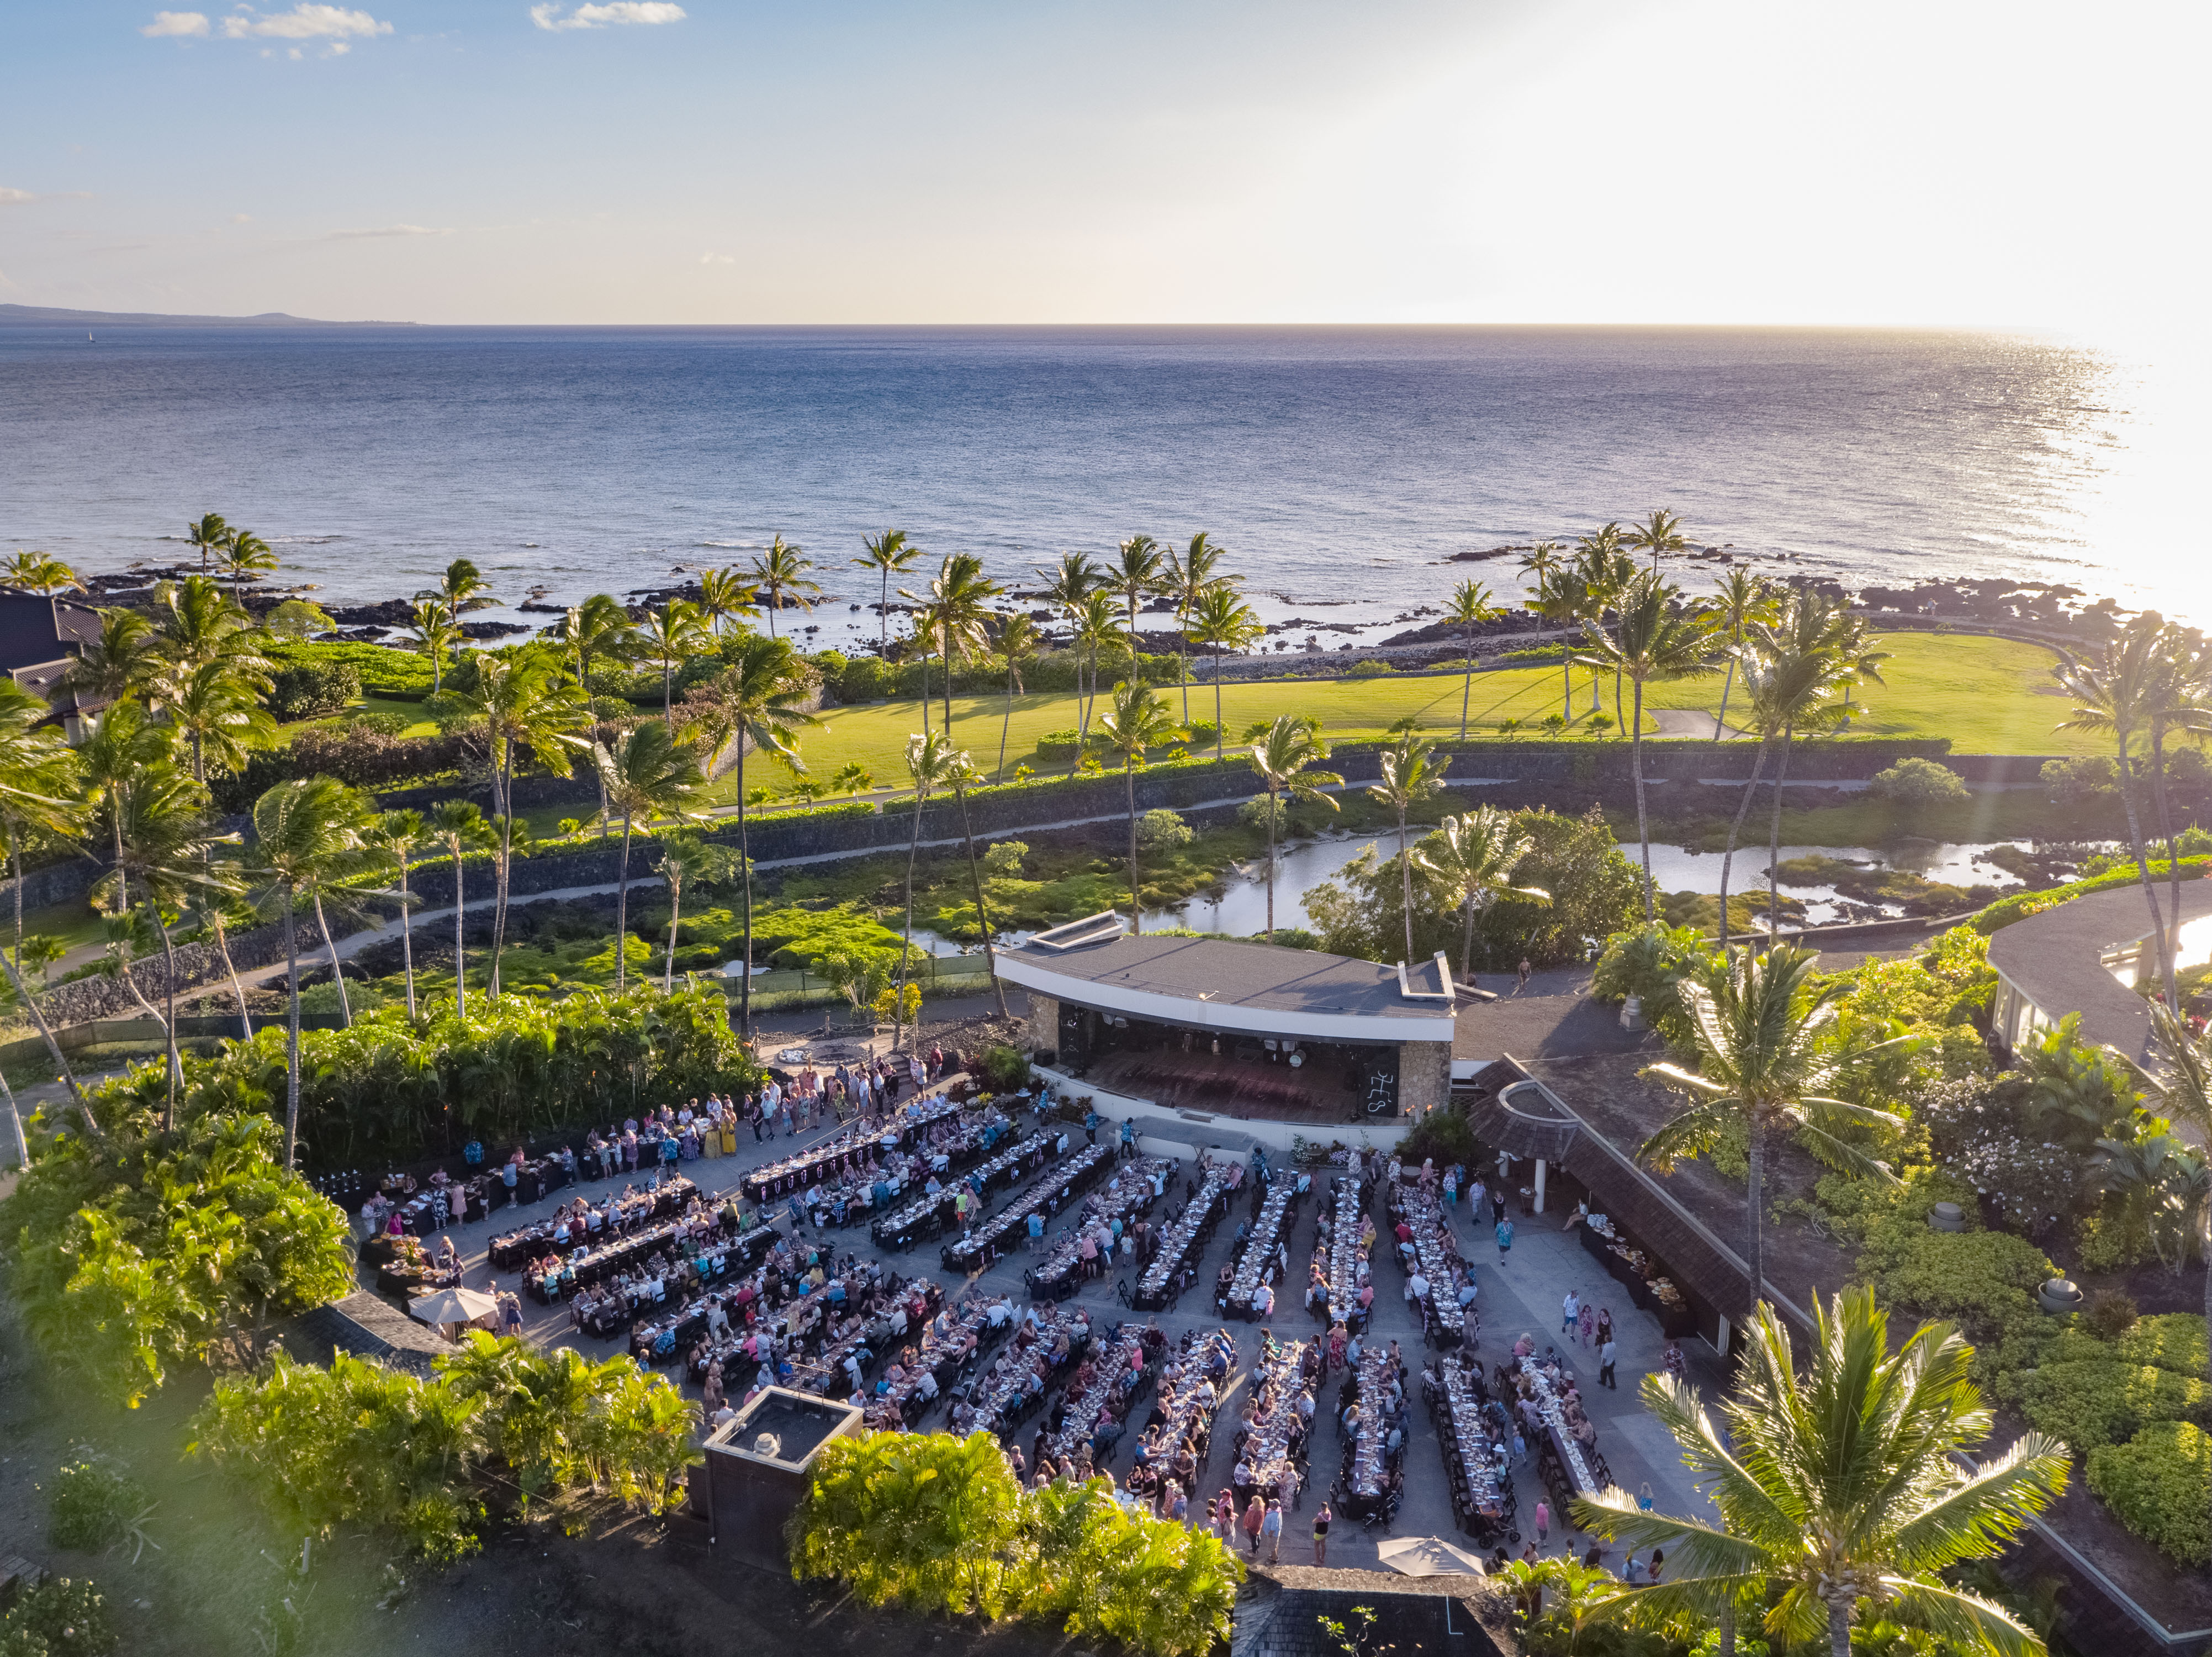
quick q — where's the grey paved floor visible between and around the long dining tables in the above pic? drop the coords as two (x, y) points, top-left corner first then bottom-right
(398, 1075), (1719, 1566)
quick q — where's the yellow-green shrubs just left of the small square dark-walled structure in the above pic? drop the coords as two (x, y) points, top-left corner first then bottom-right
(193, 1332), (697, 1560)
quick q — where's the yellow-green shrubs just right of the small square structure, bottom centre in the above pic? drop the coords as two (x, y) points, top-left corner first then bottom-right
(787, 1433), (1243, 1657)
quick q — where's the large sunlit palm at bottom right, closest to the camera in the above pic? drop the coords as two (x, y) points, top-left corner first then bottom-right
(1575, 1287), (2068, 1657)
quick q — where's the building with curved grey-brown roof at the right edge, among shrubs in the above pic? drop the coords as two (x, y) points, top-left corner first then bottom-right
(1988, 880), (2212, 1060)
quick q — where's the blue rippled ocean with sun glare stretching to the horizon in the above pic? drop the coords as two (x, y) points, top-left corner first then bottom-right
(0, 328), (2212, 644)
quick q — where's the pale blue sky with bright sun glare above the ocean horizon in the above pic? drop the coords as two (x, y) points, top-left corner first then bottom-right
(0, 0), (2212, 329)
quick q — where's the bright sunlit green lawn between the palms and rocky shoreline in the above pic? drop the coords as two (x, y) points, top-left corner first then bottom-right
(745, 633), (2106, 790)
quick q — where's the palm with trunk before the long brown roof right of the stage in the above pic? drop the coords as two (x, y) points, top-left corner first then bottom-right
(1637, 944), (1907, 1307)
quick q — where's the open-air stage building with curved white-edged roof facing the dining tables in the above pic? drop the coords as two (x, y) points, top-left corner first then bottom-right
(996, 911), (1462, 1126)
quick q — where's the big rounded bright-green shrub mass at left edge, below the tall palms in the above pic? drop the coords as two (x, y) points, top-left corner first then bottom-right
(0, 1106), (354, 1405)
